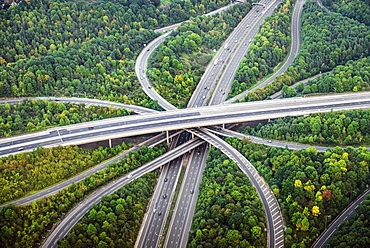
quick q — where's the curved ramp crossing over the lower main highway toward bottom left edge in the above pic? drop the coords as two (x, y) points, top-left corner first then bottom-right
(41, 138), (204, 248)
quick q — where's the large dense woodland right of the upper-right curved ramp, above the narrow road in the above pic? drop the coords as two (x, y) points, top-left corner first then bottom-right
(241, 2), (370, 101)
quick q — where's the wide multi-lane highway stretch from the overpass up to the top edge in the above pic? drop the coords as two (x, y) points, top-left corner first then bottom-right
(188, 1), (280, 107)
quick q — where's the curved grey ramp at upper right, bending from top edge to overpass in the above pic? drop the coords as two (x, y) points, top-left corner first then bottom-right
(224, 0), (305, 104)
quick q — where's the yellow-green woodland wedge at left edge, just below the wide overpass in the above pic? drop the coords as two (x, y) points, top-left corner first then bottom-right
(0, 143), (131, 204)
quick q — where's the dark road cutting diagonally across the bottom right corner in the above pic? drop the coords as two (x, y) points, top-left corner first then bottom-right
(312, 189), (370, 248)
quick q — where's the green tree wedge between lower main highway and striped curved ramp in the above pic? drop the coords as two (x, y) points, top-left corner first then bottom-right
(188, 148), (267, 248)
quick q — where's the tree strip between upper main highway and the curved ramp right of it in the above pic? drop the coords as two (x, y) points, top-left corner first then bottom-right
(227, 1), (295, 99)
